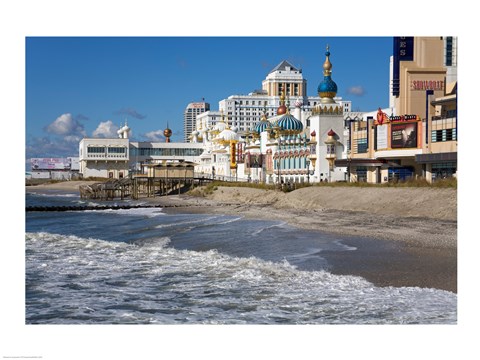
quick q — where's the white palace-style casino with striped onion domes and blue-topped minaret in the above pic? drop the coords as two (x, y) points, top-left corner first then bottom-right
(192, 47), (347, 184)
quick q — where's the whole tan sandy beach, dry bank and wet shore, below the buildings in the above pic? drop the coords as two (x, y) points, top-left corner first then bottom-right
(26, 181), (457, 292)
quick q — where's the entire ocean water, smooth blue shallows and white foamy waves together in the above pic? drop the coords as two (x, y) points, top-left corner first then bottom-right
(25, 191), (457, 324)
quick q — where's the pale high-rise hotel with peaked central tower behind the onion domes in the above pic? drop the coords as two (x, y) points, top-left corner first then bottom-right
(196, 60), (351, 135)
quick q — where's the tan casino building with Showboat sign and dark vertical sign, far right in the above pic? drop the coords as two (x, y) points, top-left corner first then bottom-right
(335, 37), (457, 183)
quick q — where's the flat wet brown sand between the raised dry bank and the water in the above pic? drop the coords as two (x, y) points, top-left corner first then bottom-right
(141, 188), (457, 293)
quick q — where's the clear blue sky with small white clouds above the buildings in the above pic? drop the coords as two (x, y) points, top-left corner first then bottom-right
(25, 36), (393, 159)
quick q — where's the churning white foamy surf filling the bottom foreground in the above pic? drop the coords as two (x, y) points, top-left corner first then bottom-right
(25, 232), (457, 324)
